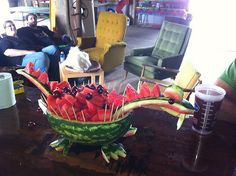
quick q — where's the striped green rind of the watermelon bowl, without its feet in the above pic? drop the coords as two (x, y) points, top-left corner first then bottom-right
(47, 113), (132, 146)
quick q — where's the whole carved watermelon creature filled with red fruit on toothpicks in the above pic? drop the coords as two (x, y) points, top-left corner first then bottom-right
(17, 64), (194, 162)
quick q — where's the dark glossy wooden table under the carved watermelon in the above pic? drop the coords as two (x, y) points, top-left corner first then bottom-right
(0, 89), (236, 176)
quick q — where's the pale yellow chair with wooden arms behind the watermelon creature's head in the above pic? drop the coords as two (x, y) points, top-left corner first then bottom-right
(139, 61), (201, 99)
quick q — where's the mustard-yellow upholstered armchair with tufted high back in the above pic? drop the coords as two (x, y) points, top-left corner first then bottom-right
(77, 11), (127, 72)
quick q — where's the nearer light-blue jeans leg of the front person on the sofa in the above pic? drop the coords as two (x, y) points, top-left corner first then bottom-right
(21, 52), (50, 72)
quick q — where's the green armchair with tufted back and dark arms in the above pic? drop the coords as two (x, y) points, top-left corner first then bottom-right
(124, 21), (191, 80)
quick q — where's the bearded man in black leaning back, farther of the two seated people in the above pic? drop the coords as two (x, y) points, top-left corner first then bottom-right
(17, 13), (73, 55)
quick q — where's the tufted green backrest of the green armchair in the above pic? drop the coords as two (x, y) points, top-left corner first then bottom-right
(152, 21), (188, 59)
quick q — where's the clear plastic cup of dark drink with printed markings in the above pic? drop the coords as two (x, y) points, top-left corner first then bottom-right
(192, 84), (226, 135)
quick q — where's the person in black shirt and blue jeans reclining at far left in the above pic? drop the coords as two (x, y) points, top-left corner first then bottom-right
(0, 20), (60, 80)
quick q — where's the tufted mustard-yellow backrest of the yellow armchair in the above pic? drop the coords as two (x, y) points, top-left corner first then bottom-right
(96, 12), (127, 48)
